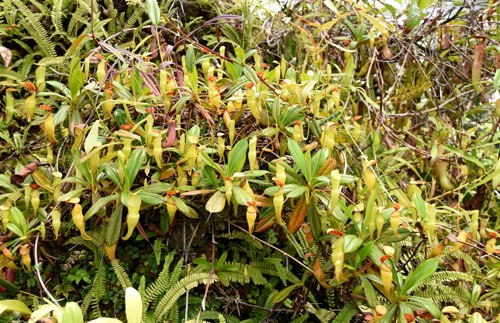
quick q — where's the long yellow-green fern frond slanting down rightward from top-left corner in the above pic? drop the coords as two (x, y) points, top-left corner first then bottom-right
(12, 0), (57, 56)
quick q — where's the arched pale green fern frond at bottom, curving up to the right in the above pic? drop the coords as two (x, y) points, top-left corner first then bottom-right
(154, 273), (217, 322)
